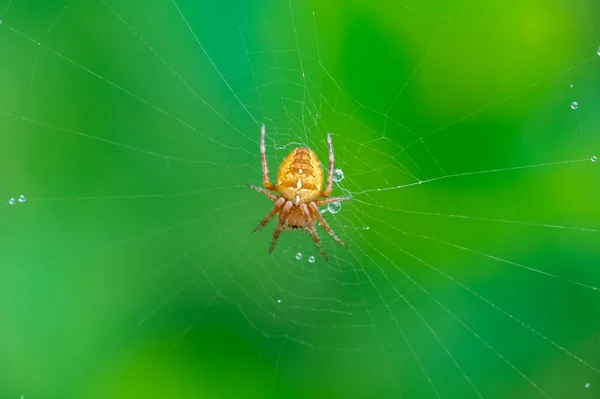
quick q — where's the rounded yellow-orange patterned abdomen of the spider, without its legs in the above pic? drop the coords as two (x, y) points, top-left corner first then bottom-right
(277, 148), (323, 205)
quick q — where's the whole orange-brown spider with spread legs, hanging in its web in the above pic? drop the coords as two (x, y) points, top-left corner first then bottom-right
(249, 124), (352, 261)
